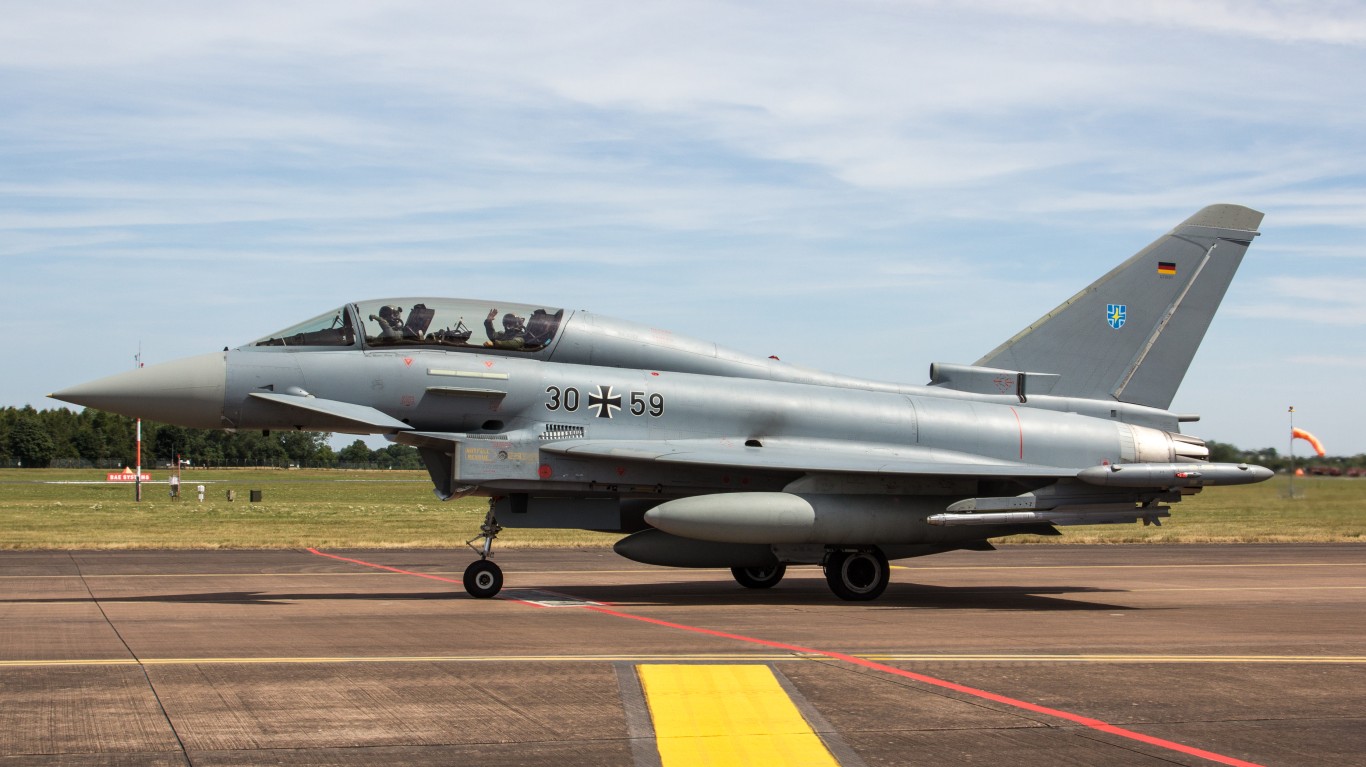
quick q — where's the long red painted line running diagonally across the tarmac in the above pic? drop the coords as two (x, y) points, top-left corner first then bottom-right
(309, 548), (1264, 767)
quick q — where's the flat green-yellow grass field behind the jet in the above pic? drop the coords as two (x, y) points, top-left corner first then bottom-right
(0, 469), (1366, 550)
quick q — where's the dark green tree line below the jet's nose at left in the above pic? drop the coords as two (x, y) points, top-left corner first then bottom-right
(0, 406), (422, 469)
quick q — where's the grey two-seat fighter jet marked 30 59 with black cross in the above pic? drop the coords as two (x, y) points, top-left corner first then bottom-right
(52, 205), (1272, 600)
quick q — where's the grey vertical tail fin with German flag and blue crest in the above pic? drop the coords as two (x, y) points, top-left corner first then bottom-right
(975, 205), (1262, 409)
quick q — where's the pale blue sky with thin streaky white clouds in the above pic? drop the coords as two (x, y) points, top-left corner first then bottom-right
(0, 0), (1366, 455)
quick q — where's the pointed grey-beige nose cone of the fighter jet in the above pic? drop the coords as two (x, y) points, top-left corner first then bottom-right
(48, 351), (228, 429)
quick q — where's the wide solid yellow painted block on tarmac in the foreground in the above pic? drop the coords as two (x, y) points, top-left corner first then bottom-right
(637, 664), (839, 767)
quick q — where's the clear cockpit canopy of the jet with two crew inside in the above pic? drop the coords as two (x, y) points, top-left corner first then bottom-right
(247, 298), (564, 353)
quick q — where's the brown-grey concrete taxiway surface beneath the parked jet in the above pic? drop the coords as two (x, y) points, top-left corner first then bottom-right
(0, 544), (1366, 767)
